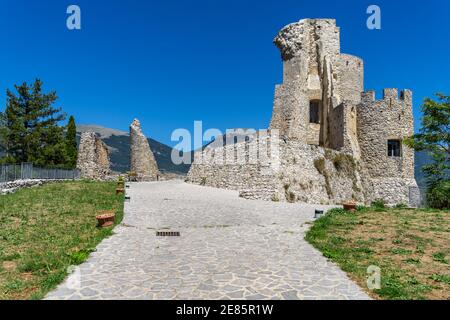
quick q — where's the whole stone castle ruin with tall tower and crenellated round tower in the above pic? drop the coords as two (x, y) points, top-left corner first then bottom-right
(187, 19), (420, 206)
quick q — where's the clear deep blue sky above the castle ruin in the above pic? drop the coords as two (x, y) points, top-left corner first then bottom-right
(0, 0), (450, 145)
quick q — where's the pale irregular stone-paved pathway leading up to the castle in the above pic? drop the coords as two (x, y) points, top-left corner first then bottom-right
(47, 181), (368, 299)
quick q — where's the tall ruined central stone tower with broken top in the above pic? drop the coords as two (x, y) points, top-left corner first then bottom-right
(270, 19), (364, 157)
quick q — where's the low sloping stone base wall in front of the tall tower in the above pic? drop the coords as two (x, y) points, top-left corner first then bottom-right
(187, 135), (370, 204)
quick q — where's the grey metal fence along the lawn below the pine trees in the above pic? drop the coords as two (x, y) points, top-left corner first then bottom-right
(0, 163), (80, 183)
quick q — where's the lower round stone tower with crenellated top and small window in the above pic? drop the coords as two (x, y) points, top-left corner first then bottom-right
(358, 89), (417, 205)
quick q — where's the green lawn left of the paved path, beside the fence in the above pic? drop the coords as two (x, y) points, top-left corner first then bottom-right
(0, 181), (124, 299)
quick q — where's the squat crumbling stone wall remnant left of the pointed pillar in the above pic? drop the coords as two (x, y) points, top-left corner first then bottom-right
(77, 132), (111, 180)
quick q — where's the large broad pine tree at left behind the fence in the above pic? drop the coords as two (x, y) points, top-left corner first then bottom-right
(4, 79), (65, 166)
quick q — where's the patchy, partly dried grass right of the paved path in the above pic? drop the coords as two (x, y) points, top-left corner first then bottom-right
(306, 208), (450, 299)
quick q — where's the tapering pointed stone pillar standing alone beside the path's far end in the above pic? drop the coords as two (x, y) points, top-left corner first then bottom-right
(130, 119), (159, 181)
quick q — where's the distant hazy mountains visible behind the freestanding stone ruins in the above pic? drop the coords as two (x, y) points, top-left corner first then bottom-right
(77, 125), (192, 174)
